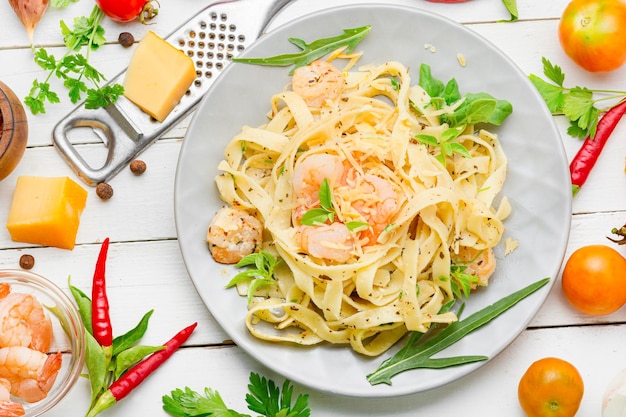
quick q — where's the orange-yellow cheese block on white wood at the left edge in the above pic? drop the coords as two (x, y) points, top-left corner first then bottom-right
(7, 176), (87, 249)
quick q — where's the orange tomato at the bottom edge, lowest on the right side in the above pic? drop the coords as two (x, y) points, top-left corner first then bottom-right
(517, 358), (585, 417)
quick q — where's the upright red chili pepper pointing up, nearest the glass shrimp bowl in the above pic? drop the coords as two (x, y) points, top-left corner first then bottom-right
(91, 238), (113, 348)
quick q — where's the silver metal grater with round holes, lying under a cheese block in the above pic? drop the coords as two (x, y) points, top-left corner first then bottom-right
(52, 0), (290, 185)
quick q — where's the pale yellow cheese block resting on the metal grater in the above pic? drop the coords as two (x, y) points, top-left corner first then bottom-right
(124, 31), (196, 122)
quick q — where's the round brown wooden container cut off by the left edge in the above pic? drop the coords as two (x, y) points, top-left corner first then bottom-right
(0, 81), (28, 181)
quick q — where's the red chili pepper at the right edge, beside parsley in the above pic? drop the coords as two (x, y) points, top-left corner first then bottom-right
(569, 100), (626, 195)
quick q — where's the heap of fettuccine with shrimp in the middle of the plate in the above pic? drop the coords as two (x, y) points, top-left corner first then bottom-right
(207, 57), (510, 356)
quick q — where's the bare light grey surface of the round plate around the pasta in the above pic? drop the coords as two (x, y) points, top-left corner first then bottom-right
(174, 4), (571, 397)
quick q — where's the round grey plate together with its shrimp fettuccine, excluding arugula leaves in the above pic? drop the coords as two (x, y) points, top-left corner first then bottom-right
(174, 4), (571, 397)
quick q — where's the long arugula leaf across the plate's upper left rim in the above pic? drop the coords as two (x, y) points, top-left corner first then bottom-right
(233, 25), (372, 75)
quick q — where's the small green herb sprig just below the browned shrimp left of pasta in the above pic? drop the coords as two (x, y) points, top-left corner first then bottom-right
(226, 250), (281, 303)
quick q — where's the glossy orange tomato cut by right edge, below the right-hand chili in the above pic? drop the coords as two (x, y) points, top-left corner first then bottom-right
(561, 245), (626, 316)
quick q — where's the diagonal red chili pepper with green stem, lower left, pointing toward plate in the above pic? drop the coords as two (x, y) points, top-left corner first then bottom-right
(85, 323), (198, 417)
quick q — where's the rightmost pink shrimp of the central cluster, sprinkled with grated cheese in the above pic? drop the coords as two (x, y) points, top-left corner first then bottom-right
(352, 174), (400, 245)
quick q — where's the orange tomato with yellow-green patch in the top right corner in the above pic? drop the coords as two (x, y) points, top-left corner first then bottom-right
(559, 0), (626, 72)
